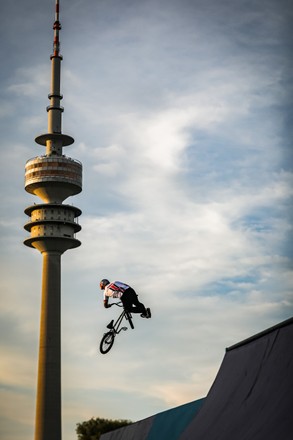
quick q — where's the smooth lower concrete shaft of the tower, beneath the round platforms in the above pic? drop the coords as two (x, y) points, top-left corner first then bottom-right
(35, 251), (62, 440)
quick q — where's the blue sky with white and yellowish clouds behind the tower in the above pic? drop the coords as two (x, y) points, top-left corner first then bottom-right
(0, 0), (293, 440)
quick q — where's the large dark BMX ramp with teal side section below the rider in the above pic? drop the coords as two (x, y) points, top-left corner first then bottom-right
(101, 318), (293, 440)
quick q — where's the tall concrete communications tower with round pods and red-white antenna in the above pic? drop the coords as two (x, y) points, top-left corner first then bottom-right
(24, 0), (82, 440)
